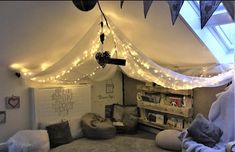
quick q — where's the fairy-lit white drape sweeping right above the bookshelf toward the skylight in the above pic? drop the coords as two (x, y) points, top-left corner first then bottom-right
(111, 28), (234, 90)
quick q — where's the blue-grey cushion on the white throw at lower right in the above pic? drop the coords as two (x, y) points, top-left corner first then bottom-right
(187, 114), (223, 147)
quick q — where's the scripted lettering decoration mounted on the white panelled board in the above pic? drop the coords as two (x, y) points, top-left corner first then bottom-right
(52, 88), (74, 116)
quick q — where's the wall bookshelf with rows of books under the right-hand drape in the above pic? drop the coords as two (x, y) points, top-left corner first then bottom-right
(137, 85), (193, 130)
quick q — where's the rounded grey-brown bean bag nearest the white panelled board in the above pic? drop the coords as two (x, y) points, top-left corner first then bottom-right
(81, 113), (116, 139)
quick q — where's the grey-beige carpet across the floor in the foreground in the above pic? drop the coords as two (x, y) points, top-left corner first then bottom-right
(50, 135), (174, 152)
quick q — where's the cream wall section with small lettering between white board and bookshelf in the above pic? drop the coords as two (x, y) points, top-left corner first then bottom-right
(91, 71), (123, 116)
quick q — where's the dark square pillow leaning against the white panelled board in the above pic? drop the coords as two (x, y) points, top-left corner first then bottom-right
(46, 121), (73, 148)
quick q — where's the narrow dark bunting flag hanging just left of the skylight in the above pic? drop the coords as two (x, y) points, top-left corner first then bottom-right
(168, 0), (184, 25)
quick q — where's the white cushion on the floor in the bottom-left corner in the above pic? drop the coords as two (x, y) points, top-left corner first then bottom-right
(7, 130), (50, 152)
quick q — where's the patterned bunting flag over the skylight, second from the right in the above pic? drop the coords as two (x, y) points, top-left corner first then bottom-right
(200, 0), (221, 28)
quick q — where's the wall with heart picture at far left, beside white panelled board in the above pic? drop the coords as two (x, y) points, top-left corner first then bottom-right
(0, 67), (30, 143)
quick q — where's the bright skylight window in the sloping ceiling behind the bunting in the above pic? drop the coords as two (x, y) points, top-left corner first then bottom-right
(180, 1), (235, 64)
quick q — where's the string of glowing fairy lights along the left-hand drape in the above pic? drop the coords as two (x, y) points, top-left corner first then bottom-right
(24, 24), (116, 84)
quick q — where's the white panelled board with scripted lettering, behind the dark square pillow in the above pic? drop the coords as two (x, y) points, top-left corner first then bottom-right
(30, 85), (91, 129)
